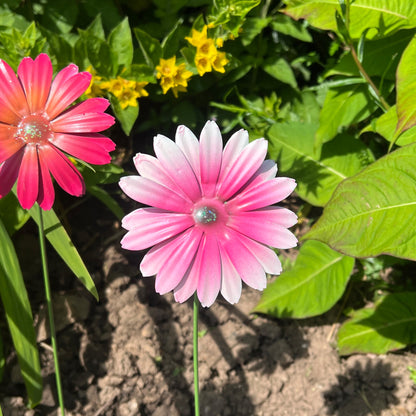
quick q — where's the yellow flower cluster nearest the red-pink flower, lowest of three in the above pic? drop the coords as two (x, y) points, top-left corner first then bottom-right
(85, 67), (149, 110)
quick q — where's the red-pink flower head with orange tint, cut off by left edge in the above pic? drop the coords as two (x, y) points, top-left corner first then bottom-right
(0, 54), (115, 210)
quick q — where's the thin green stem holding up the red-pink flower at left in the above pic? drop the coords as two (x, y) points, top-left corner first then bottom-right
(38, 206), (65, 416)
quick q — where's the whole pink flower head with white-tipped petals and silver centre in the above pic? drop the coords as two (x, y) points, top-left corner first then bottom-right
(120, 121), (297, 307)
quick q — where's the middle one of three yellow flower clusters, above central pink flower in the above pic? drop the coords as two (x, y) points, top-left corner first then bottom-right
(156, 56), (192, 98)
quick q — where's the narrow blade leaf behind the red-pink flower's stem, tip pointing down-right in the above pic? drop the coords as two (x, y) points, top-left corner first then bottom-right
(29, 205), (98, 300)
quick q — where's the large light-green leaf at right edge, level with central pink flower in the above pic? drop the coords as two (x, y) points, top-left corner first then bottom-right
(305, 144), (416, 260)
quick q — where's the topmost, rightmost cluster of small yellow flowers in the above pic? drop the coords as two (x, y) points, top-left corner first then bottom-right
(185, 25), (228, 76)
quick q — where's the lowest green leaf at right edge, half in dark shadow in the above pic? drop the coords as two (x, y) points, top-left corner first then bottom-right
(338, 292), (416, 355)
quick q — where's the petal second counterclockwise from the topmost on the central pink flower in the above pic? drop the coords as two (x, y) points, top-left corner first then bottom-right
(153, 134), (201, 201)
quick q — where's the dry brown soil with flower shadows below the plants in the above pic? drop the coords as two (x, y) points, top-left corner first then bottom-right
(0, 193), (416, 416)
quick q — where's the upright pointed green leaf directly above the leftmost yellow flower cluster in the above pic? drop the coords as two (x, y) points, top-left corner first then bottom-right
(108, 17), (133, 76)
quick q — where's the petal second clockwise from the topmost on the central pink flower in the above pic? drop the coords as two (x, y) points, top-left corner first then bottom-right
(218, 139), (267, 200)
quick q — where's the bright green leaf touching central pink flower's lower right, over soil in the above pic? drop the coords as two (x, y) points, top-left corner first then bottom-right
(254, 241), (354, 318)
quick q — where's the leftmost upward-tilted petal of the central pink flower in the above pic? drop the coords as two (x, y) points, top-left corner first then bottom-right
(119, 176), (191, 213)
